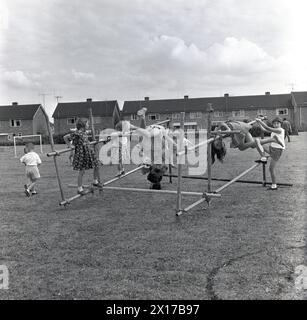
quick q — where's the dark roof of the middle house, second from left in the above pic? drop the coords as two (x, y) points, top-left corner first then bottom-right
(52, 100), (118, 119)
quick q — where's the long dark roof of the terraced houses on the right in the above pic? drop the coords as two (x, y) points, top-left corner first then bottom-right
(123, 94), (291, 115)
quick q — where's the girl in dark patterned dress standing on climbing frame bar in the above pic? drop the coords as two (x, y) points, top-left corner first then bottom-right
(64, 119), (102, 195)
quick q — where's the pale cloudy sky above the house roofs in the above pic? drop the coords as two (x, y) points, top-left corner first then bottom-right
(0, 0), (307, 118)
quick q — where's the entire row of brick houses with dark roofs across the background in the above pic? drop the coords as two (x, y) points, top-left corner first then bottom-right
(0, 91), (307, 140)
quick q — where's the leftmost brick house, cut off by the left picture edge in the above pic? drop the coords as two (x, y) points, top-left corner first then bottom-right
(0, 102), (48, 142)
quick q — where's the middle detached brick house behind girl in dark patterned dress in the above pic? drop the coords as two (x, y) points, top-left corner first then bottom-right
(52, 99), (120, 135)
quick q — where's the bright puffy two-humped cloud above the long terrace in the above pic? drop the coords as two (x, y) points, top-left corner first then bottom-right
(141, 35), (277, 77)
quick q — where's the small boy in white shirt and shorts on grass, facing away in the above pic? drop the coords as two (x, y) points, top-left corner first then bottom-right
(20, 143), (42, 197)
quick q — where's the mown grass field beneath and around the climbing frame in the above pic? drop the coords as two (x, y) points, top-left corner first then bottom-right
(0, 133), (307, 300)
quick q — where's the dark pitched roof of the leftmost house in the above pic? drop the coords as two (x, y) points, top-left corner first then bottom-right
(0, 104), (41, 120)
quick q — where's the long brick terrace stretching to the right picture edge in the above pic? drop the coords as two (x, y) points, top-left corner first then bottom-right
(123, 92), (307, 130)
